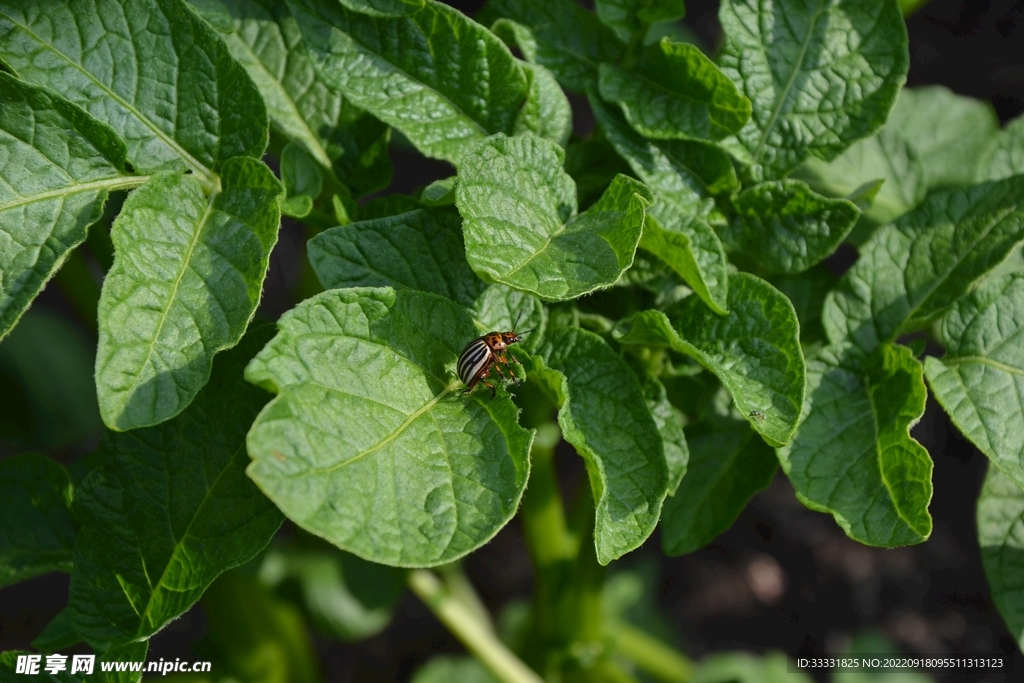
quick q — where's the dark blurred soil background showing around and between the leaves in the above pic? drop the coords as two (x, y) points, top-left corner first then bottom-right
(0, 0), (1024, 683)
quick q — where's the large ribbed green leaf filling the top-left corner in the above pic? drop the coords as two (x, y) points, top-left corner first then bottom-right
(0, 0), (267, 177)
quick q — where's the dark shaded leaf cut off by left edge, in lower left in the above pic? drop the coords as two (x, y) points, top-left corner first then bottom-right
(0, 454), (77, 588)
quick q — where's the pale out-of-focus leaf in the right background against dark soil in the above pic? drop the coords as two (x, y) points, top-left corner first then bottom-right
(797, 86), (1009, 225)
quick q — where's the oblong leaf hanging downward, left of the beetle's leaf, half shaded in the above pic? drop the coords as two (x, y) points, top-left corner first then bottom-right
(96, 158), (281, 431)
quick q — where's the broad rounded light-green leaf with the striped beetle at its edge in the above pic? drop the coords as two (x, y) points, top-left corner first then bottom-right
(246, 289), (532, 566)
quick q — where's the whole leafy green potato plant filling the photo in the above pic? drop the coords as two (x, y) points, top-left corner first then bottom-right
(0, 0), (1024, 683)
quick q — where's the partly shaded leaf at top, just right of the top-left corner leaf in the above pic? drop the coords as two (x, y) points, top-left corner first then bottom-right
(202, 0), (391, 199)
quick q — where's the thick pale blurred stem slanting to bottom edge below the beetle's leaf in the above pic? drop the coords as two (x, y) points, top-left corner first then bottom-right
(408, 569), (544, 683)
